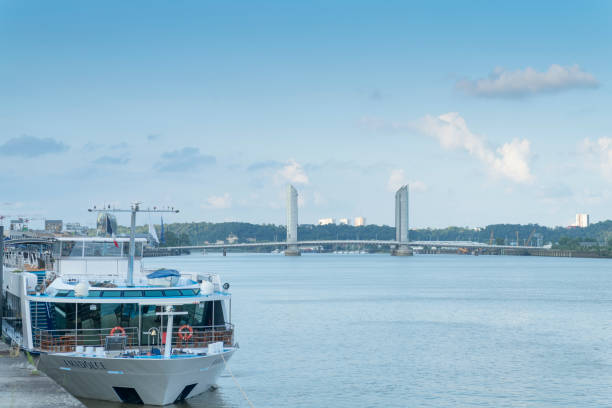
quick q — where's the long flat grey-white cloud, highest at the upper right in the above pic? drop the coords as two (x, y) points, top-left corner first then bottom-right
(456, 64), (599, 98)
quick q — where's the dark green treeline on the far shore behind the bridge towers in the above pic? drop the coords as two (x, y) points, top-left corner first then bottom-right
(119, 221), (612, 246)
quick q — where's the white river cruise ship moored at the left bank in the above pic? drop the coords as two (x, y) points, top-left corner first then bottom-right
(0, 237), (237, 405)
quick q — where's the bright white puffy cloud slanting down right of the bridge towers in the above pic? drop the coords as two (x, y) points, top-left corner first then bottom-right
(417, 112), (533, 183)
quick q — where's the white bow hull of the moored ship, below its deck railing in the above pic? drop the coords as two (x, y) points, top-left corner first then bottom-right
(38, 348), (235, 405)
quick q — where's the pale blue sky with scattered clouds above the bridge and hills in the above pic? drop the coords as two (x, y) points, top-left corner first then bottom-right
(0, 1), (612, 227)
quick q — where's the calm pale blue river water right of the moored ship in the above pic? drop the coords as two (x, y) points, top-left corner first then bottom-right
(84, 253), (612, 408)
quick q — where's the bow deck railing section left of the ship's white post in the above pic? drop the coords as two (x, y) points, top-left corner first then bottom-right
(32, 327), (138, 353)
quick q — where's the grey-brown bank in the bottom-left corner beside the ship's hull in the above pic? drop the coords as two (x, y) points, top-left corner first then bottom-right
(0, 341), (85, 408)
